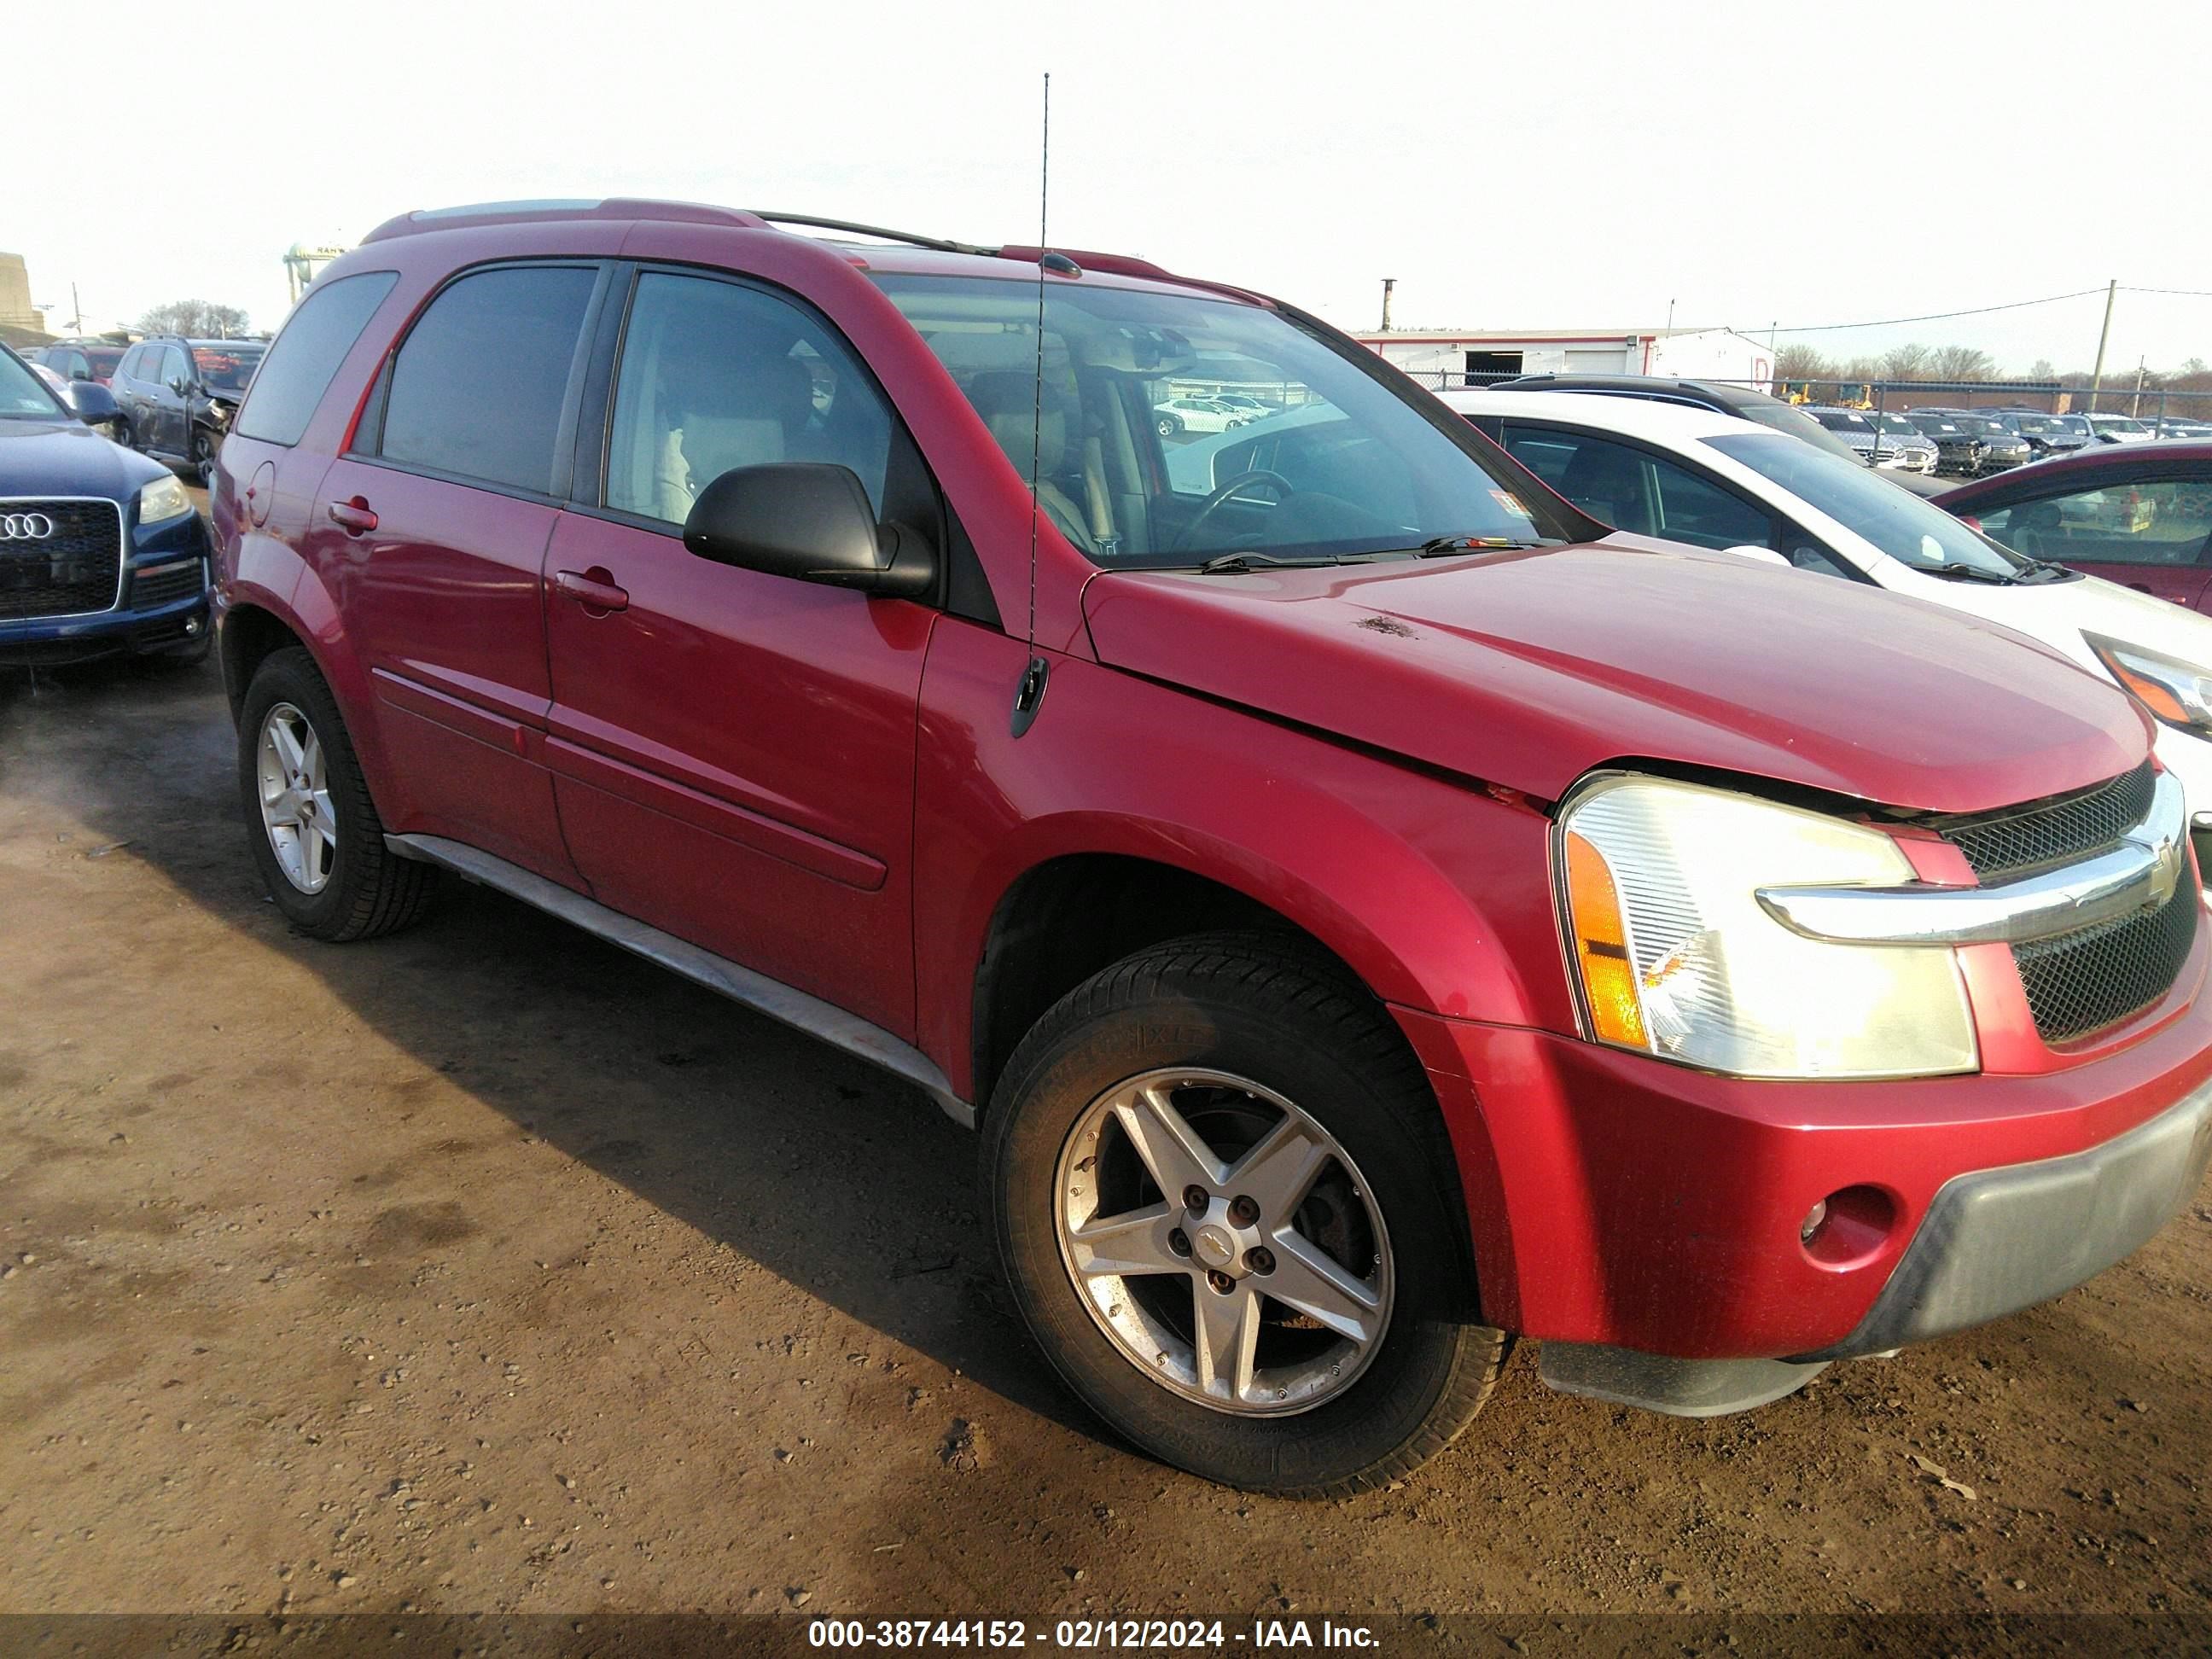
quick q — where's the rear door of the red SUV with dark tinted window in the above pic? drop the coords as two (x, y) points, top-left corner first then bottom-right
(307, 261), (604, 887)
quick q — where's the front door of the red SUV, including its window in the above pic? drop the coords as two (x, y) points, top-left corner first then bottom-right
(546, 268), (945, 1035)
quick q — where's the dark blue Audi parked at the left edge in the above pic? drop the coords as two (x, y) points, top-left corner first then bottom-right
(0, 345), (210, 666)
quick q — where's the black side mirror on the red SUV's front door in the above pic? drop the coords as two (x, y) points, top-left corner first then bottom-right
(684, 460), (938, 599)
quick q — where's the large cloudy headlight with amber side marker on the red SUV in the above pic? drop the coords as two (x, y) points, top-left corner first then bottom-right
(1557, 777), (1980, 1092)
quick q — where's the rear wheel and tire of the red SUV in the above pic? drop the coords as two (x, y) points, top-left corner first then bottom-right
(239, 646), (438, 942)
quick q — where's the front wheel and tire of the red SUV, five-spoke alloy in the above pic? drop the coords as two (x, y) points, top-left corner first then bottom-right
(982, 934), (1511, 1498)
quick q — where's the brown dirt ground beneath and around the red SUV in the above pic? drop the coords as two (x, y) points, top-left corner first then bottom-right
(0, 632), (2212, 1617)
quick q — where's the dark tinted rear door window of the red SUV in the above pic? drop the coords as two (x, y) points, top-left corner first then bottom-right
(378, 265), (599, 496)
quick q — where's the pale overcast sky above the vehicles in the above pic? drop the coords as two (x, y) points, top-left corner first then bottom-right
(17, 0), (2212, 371)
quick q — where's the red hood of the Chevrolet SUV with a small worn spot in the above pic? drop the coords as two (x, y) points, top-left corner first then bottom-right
(1084, 535), (2150, 812)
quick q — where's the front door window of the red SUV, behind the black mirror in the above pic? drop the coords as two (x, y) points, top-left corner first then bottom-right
(606, 272), (892, 524)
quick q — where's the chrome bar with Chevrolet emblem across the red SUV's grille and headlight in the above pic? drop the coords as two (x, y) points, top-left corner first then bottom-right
(1756, 772), (2190, 945)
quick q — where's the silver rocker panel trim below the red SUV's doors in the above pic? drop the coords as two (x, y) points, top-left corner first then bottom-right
(385, 834), (975, 1128)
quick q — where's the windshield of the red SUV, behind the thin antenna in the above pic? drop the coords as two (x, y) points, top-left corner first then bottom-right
(874, 272), (1575, 568)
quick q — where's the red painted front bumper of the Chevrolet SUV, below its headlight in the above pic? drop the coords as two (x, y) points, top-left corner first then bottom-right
(1398, 935), (2212, 1380)
